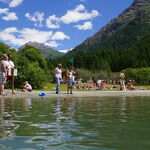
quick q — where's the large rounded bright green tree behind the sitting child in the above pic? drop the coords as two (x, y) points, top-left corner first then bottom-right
(15, 46), (49, 88)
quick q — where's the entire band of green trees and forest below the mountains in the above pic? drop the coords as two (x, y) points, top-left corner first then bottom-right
(0, 34), (150, 89)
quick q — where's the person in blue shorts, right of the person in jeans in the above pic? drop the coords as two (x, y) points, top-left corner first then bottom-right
(67, 68), (75, 94)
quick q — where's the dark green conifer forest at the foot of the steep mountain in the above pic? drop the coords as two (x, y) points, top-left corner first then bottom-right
(48, 34), (150, 72)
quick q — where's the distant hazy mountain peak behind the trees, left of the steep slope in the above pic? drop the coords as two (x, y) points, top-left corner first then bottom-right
(19, 42), (64, 58)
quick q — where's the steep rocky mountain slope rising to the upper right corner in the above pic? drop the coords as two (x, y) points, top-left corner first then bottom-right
(68, 0), (150, 54)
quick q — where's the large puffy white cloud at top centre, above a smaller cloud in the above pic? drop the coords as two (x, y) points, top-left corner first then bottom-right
(61, 5), (99, 24)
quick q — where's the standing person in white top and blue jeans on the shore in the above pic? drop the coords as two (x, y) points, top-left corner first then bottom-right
(53, 64), (62, 94)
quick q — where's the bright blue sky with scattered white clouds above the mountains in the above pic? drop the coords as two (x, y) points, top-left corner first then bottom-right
(0, 0), (133, 50)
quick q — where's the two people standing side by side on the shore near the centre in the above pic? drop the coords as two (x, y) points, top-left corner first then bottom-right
(53, 64), (75, 94)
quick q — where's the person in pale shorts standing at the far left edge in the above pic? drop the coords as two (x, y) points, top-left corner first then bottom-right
(0, 54), (8, 95)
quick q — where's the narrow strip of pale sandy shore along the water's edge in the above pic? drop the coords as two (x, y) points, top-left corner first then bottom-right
(0, 90), (150, 99)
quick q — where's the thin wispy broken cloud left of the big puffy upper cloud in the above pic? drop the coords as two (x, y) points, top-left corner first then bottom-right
(25, 12), (44, 27)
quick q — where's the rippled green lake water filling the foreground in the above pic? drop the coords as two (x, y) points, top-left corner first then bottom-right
(0, 97), (150, 150)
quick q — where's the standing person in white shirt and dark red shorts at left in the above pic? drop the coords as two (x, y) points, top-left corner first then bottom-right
(7, 54), (15, 92)
